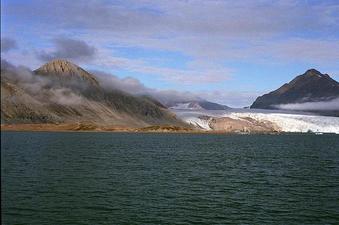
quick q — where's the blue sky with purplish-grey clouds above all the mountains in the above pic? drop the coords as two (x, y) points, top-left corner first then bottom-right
(1, 0), (339, 107)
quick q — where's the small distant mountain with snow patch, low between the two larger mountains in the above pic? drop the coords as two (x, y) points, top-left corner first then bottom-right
(167, 100), (230, 110)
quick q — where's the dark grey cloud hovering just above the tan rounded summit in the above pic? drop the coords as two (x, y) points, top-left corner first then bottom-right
(37, 38), (96, 61)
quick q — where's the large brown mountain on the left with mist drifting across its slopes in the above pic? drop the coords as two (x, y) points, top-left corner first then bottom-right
(1, 60), (185, 127)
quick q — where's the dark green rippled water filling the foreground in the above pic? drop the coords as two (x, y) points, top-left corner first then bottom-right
(1, 132), (339, 224)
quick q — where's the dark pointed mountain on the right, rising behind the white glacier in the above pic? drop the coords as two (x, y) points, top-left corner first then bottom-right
(251, 69), (339, 114)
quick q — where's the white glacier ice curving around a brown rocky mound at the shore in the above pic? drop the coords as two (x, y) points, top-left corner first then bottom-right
(175, 109), (339, 134)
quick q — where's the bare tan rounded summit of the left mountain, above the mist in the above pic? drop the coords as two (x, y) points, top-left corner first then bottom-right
(34, 59), (99, 86)
